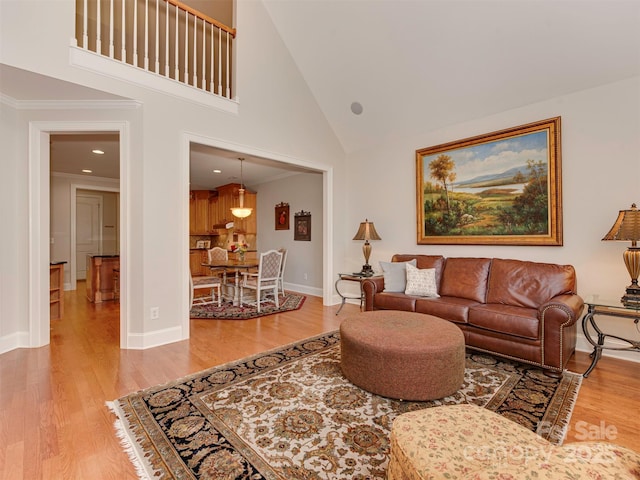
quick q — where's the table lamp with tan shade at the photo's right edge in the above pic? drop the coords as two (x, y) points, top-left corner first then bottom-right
(602, 203), (640, 306)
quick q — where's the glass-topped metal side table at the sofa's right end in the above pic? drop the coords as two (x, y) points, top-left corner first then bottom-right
(582, 295), (640, 378)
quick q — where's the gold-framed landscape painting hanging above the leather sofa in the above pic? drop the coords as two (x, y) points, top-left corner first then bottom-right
(416, 117), (562, 246)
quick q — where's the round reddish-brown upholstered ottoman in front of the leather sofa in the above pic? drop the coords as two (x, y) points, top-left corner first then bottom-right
(340, 310), (465, 401)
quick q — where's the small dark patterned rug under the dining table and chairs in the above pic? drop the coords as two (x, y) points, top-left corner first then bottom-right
(190, 293), (306, 320)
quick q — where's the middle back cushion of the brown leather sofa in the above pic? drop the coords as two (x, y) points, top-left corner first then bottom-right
(440, 258), (491, 303)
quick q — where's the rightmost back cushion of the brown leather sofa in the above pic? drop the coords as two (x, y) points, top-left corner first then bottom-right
(487, 258), (576, 308)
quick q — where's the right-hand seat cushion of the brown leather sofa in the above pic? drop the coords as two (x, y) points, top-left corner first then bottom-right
(469, 304), (540, 340)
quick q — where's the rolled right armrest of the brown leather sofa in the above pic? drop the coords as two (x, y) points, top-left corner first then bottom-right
(538, 295), (584, 371)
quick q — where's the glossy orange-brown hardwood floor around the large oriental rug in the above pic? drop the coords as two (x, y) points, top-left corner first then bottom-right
(0, 288), (640, 480)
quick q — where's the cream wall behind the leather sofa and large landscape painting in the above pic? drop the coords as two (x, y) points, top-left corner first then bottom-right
(343, 77), (640, 359)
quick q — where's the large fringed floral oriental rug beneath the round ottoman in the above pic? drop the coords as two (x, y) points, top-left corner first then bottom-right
(108, 331), (582, 480)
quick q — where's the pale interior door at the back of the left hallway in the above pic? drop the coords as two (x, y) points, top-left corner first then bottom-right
(76, 194), (102, 280)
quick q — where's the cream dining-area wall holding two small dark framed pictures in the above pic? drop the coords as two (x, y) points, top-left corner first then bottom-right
(257, 173), (323, 296)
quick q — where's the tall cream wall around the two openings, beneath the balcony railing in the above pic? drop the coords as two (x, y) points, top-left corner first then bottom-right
(0, 0), (344, 348)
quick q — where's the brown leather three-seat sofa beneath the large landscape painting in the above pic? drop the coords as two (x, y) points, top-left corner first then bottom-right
(362, 255), (584, 375)
